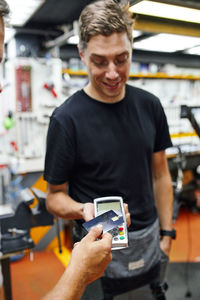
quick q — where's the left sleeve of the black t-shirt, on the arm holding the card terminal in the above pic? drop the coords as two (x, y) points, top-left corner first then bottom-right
(44, 116), (75, 185)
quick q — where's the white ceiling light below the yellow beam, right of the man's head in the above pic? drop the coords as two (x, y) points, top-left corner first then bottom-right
(133, 33), (200, 52)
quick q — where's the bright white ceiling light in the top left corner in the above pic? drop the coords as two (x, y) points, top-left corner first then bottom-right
(7, 0), (45, 26)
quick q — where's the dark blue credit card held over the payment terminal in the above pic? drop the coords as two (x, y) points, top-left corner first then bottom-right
(83, 210), (123, 233)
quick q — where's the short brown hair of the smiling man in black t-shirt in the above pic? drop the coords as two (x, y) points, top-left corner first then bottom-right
(79, 0), (133, 51)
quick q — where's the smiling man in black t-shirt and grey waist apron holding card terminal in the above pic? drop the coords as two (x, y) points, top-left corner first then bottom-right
(44, 0), (173, 300)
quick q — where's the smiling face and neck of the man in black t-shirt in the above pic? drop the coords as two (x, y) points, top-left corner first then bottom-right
(80, 32), (132, 103)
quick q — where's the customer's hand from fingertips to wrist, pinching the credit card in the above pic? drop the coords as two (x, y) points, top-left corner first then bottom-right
(69, 225), (112, 285)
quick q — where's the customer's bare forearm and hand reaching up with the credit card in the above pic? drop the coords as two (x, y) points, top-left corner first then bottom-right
(43, 225), (112, 300)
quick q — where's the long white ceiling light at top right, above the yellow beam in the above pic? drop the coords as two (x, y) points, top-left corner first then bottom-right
(129, 0), (200, 23)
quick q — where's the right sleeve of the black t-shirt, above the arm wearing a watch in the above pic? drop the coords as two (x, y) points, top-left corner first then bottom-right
(154, 100), (172, 152)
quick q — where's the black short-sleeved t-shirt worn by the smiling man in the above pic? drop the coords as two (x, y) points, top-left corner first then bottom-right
(44, 85), (172, 230)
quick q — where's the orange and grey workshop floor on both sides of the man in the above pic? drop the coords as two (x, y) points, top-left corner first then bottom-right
(0, 209), (200, 300)
